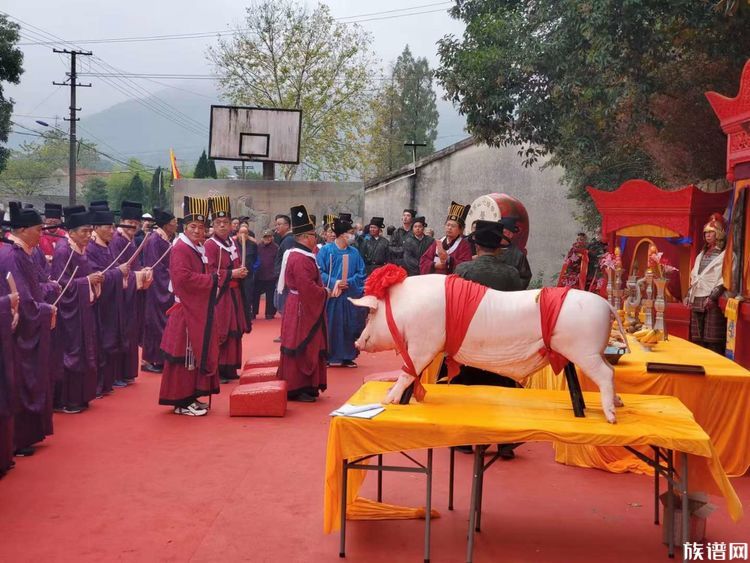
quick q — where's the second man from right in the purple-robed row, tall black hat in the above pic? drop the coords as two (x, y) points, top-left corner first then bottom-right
(110, 201), (151, 384)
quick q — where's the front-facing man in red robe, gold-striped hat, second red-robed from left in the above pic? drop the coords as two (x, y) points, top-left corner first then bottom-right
(206, 196), (250, 383)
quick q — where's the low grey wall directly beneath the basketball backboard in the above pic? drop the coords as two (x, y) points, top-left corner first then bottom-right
(174, 178), (364, 234)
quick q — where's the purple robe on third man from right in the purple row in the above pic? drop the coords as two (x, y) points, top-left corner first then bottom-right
(86, 240), (128, 393)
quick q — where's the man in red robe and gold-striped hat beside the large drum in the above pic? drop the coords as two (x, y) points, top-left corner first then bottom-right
(419, 201), (471, 274)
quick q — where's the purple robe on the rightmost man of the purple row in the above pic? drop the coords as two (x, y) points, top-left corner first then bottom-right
(141, 232), (174, 364)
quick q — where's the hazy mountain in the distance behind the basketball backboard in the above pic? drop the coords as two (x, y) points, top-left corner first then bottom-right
(9, 82), (467, 171)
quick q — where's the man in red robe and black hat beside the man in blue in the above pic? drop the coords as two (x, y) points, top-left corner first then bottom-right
(277, 205), (328, 403)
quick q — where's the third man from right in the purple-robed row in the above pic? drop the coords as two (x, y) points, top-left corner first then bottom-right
(86, 206), (130, 398)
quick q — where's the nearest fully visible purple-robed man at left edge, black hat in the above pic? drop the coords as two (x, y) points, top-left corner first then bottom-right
(0, 202), (56, 456)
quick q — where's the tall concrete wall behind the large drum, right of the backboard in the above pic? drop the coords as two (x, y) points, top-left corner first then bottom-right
(365, 139), (581, 285)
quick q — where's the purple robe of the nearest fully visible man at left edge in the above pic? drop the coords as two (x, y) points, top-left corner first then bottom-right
(0, 244), (52, 449)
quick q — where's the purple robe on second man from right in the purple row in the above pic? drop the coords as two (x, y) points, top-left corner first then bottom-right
(109, 230), (142, 379)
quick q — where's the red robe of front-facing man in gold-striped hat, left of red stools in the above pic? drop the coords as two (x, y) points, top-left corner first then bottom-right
(205, 235), (250, 376)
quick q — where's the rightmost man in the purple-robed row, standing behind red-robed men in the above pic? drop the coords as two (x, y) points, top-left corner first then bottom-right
(142, 207), (177, 373)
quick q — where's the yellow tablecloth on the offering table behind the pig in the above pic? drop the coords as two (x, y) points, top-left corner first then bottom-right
(526, 337), (750, 477)
